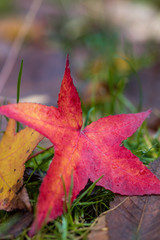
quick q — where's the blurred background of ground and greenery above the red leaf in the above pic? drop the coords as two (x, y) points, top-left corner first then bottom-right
(0, 0), (160, 131)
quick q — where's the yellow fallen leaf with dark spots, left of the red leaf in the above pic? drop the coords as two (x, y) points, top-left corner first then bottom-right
(0, 119), (43, 211)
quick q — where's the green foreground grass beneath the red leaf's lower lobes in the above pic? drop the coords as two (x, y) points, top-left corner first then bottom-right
(0, 160), (114, 240)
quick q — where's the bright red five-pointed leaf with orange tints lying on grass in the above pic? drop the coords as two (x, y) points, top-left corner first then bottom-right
(0, 58), (160, 236)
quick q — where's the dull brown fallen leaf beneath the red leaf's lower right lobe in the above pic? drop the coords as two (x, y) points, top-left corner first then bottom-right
(88, 159), (160, 240)
